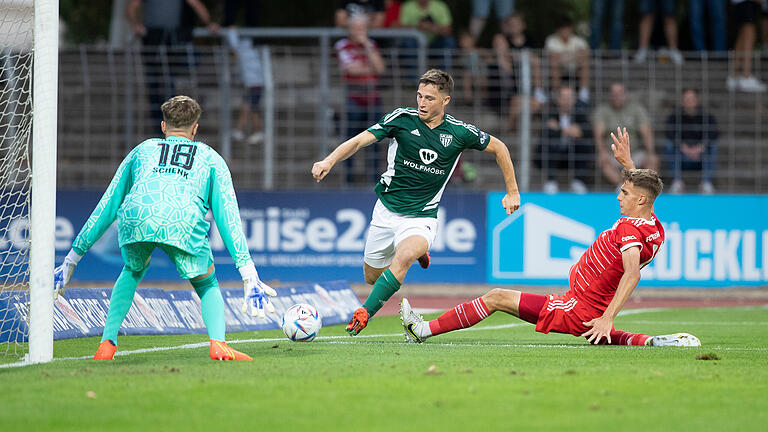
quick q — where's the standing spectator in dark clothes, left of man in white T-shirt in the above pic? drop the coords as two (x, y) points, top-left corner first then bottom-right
(493, 12), (547, 131)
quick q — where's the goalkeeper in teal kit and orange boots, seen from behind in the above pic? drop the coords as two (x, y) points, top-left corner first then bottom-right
(54, 96), (276, 360)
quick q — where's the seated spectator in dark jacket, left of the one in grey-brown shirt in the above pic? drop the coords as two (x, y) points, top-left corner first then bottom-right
(535, 87), (594, 194)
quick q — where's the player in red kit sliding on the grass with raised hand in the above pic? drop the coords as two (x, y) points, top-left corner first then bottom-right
(400, 128), (701, 346)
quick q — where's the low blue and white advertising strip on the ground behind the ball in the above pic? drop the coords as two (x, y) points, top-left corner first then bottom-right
(0, 281), (360, 343)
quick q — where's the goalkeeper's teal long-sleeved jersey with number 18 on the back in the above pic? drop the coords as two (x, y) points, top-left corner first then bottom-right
(72, 136), (251, 268)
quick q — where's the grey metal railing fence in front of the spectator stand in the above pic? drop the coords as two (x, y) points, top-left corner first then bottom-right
(59, 33), (768, 193)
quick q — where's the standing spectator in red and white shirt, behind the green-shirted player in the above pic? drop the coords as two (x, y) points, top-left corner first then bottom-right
(334, 15), (384, 183)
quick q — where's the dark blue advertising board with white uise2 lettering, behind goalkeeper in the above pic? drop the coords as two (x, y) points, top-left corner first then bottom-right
(0, 191), (486, 283)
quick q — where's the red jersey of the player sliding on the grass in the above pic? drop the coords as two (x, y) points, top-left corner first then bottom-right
(566, 214), (664, 314)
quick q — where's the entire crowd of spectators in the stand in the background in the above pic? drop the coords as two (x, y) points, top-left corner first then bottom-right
(127, 0), (768, 193)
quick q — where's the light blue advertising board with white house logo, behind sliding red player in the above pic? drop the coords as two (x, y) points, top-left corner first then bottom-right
(486, 193), (768, 288)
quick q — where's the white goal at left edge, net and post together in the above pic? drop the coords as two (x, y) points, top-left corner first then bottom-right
(0, 0), (58, 362)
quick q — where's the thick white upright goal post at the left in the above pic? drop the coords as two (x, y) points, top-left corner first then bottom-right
(28, 0), (59, 363)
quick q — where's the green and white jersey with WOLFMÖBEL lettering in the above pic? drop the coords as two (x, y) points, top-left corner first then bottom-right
(368, 108), (490, 217)
